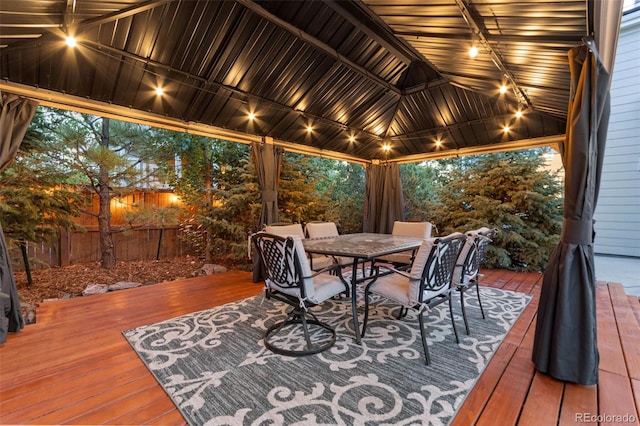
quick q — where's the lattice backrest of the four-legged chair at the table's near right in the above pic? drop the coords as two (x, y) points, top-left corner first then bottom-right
(409, 232), (466, 304)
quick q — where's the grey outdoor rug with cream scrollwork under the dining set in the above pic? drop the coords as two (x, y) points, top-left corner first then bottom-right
(124, 288), (530, 425)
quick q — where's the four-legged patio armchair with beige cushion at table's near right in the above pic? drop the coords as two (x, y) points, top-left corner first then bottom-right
(362, 233), (466, 365)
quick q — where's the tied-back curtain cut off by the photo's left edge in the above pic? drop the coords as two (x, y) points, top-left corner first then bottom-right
(0, 93), (38, 344)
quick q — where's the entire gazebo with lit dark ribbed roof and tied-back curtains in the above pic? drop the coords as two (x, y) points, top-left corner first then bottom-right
(0, 0), (622, 383)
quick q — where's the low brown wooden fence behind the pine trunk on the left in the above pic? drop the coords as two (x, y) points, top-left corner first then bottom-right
(11, 226), (195, 270)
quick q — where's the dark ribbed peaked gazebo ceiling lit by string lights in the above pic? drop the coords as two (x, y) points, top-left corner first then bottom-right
(0, 0), (593, 162)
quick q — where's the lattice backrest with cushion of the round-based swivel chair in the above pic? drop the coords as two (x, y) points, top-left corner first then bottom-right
(251, 232), (315, 299)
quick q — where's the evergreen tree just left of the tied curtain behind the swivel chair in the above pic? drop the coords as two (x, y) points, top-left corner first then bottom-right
(163, 132), (260, 262)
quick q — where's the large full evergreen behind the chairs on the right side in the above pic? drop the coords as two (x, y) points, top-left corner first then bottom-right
(431, 149), (562, 271)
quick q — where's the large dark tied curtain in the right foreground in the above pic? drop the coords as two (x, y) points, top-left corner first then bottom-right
(532, 40), (610, 385)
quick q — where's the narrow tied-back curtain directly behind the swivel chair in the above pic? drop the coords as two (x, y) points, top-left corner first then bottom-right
(251, 142), (284, 282)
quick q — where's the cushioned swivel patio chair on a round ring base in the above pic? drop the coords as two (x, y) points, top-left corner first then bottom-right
(251, 232), (349, 356)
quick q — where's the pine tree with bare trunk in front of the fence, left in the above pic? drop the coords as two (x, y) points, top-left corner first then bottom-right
(24, 109), (171, 269)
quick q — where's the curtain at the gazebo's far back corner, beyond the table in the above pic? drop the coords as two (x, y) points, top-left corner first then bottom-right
(363, 163), (404, 234)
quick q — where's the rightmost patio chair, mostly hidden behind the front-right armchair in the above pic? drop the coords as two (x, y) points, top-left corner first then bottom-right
(453, 227), (498, 334)
